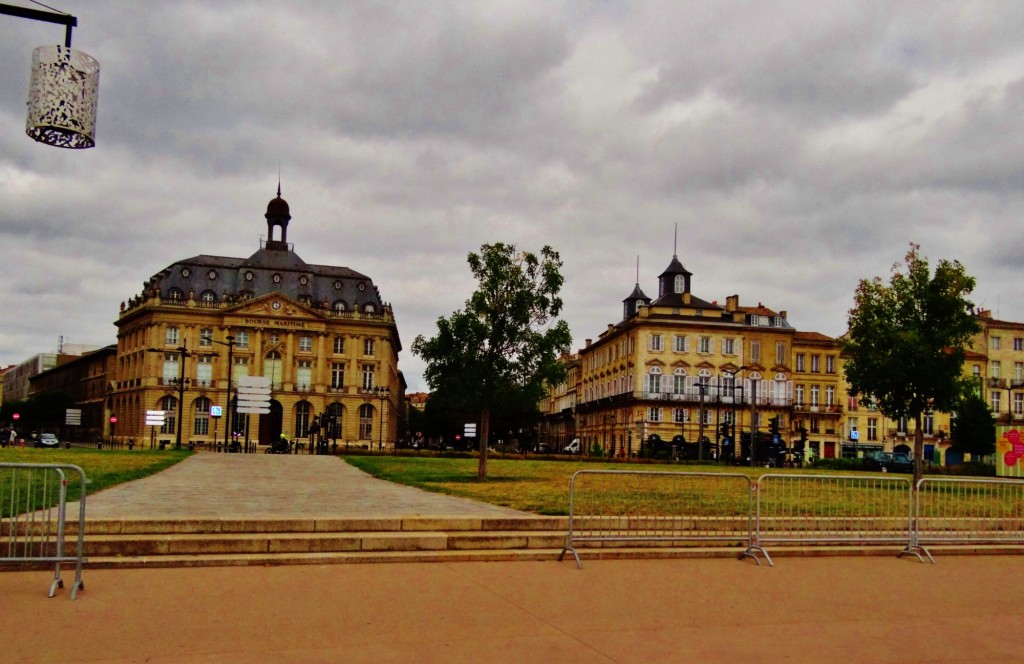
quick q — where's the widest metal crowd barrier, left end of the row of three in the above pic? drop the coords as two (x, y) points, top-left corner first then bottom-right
(558, 470), (761, 568)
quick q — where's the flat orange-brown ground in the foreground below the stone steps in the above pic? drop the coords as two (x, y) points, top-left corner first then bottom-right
(0, 555), (1024, 664)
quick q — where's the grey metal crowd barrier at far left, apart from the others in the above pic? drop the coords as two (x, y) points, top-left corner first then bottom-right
(0, 463), (86, 599)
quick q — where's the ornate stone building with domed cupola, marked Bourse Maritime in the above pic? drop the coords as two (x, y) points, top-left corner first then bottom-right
(110, 188), (404, 448)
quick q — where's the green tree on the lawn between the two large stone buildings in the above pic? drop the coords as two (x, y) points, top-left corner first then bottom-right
(413, 243), (572, 481)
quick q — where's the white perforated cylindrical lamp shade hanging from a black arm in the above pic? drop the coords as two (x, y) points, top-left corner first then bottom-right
(25, 46), (99, 150)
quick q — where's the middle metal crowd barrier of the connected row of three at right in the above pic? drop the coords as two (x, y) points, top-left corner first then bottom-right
(752, 473), (924, 565)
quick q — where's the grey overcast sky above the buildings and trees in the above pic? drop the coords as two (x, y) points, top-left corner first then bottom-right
(0, 0), (1024, 391)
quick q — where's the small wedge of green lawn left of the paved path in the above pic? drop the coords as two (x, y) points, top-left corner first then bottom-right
(0, 447), (193, 517)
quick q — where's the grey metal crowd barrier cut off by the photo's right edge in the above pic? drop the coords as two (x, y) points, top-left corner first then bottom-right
(914, 478), (1024, 562)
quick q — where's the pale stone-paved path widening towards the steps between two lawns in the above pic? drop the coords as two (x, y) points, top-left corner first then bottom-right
(68, 452), (526, 518)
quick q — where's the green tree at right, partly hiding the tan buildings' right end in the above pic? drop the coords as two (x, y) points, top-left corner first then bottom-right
(843, 244), (979, 486)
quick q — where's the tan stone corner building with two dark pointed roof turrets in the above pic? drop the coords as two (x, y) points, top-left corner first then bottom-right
(565, 256), (844, 463)
